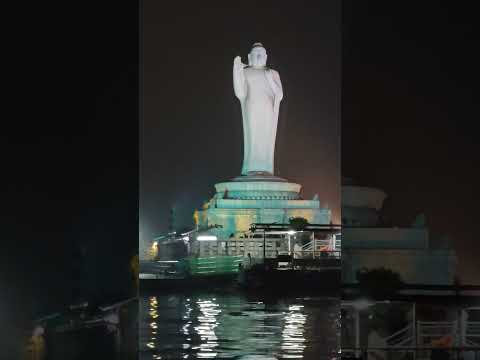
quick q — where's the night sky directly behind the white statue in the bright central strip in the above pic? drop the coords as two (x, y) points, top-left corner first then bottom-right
(140, 0), (341, 236)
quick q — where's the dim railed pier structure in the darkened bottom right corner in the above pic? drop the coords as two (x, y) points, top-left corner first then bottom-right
(341, 298), (480, 360)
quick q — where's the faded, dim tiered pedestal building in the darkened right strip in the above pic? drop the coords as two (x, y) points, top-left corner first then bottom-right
(342, 179), (456, 285)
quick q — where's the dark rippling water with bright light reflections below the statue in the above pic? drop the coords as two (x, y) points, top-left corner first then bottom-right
(139, 293), (340, 360)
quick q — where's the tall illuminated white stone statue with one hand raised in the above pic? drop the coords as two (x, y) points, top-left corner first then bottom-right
(233, 43), (283, 175)
